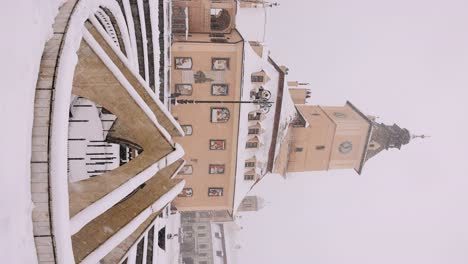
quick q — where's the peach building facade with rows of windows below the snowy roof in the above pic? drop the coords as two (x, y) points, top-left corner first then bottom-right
(170, 30), (244, 210)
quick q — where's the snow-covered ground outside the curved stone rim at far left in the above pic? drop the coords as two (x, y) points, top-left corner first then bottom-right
(0, 0), (63, 264)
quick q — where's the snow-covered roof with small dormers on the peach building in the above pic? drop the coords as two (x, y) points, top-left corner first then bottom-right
(233, 42), (295, 212)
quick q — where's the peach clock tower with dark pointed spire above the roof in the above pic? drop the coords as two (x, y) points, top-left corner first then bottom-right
(286, 102), (416, 174)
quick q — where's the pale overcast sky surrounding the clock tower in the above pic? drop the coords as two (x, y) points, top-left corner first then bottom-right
(237, 0), (468, 264)
